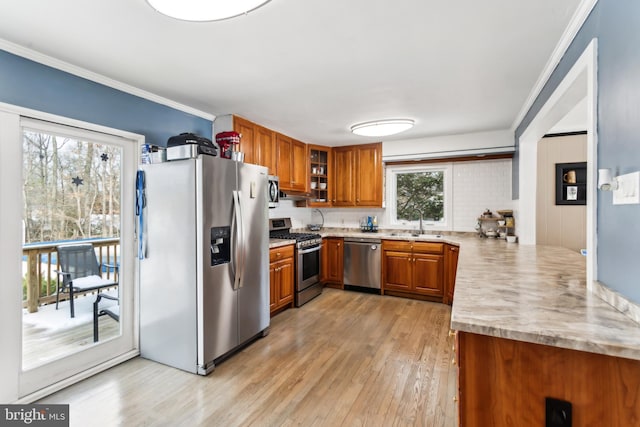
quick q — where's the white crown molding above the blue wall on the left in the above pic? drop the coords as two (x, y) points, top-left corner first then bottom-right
(0, 39), (215, 121)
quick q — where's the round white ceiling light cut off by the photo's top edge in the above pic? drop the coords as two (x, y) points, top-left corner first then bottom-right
(147, 0), (270, 21)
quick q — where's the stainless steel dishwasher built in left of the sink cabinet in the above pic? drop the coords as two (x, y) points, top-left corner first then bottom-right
(344, 237), (381, 293)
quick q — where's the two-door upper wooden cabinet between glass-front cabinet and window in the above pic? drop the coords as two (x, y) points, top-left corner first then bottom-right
(331, 143), (382, 207)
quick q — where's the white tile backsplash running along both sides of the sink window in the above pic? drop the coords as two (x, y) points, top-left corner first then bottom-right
(269, 159), (517, 233)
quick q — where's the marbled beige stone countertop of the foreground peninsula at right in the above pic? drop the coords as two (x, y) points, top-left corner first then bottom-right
(451, 237), (640, 360)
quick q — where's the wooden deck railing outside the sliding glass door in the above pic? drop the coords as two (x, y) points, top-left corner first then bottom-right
(22, 238), (120, 313)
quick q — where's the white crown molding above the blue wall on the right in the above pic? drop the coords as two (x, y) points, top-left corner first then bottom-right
(511, 0), (598, 132)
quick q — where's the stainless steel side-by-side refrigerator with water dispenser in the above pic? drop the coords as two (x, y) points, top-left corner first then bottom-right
(140, 154), (269, 375)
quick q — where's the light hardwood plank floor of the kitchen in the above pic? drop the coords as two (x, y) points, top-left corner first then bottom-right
(40, 289), (456, 427)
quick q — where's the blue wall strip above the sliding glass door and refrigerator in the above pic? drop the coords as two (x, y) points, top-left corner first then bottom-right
(0, 50), (212, 146)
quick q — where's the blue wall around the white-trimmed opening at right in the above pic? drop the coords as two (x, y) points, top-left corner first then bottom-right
(513, 0), (640, 303)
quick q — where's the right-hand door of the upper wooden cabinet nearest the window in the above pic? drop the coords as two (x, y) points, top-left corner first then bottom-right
(355, 143), (382, 207)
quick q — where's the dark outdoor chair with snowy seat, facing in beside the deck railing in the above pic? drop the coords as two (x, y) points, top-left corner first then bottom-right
(56, 243), (118, 317)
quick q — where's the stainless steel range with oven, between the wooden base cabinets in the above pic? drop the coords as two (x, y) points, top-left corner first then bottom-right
(269, 218), (322, 307)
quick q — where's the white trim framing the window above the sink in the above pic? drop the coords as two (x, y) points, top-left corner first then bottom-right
(386, 162), (453, 231)
